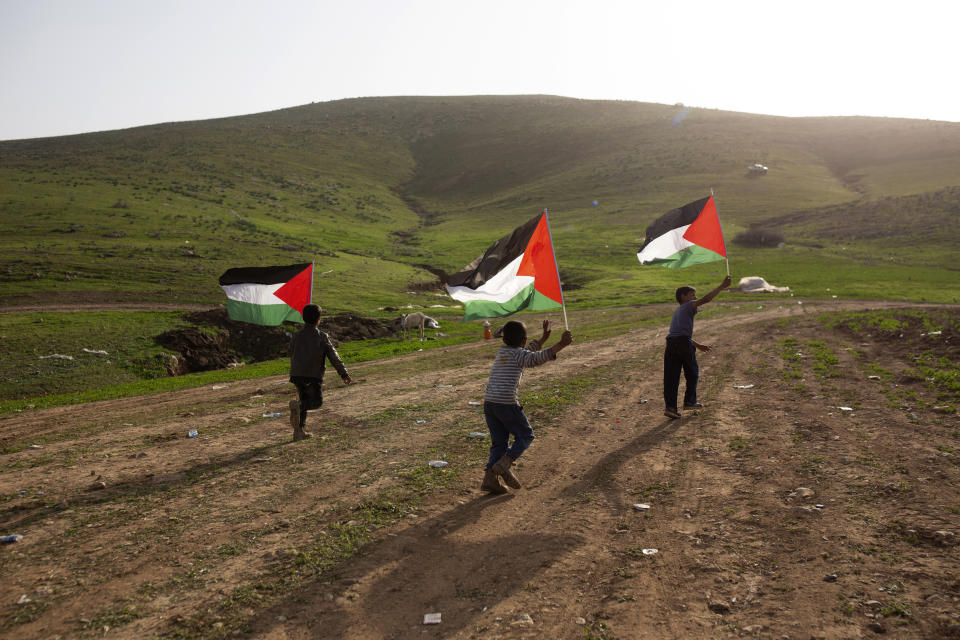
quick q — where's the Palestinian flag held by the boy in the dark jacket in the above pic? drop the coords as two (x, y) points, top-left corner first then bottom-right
(220, 262), (313, 327)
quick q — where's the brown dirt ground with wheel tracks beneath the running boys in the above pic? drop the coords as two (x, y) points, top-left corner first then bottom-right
(0, 303), (960, 640)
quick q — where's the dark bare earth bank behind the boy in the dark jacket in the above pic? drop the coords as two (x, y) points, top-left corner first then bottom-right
(156, 307), (399, 375)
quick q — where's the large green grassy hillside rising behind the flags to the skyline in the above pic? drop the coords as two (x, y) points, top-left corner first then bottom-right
(0, 96), (960, 312)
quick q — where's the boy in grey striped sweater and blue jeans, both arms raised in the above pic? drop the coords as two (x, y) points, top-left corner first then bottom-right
(480, 320), (573, 493)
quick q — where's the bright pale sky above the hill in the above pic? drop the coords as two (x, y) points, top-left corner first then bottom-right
(0, 0), (960, 140)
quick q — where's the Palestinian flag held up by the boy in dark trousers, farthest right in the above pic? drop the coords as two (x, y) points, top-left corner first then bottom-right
(637, 196), (727, 269)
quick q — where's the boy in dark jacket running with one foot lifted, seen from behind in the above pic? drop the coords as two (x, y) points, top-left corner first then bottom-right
(290, 304), (353, 442)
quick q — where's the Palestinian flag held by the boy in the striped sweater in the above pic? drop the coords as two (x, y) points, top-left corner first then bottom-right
(447, 211), (563, 320)
